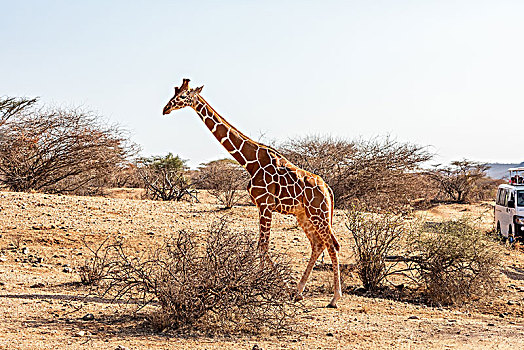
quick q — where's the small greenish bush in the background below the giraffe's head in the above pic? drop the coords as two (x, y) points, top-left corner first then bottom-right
(138, 153), (196, 201)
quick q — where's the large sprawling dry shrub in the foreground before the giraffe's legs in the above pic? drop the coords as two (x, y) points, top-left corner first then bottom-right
(84, 220), (299, 333)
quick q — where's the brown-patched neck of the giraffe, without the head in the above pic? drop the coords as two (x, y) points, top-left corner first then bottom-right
(193, 96), (271, 174)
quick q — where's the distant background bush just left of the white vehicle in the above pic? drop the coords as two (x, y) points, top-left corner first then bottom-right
(428, 159), (496, 203)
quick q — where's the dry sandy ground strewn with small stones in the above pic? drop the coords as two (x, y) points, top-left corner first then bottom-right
(0, 190), (524, 349)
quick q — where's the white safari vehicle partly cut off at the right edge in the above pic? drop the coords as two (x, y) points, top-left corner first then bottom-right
(495, 167), (524, 242)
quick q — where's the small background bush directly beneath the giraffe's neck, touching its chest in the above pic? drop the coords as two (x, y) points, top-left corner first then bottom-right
(197, 159), (249, 208)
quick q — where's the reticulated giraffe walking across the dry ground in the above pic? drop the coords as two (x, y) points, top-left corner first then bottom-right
(163, 79), (342, 307)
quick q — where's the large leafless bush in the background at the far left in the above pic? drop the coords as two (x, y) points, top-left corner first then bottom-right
(0, 104), (135, 193)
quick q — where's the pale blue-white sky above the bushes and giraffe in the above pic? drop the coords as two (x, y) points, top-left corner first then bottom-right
(0, 0), (524, 167)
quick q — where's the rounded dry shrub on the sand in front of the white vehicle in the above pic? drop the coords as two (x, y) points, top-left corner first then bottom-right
(409, 219), (501, 304)
